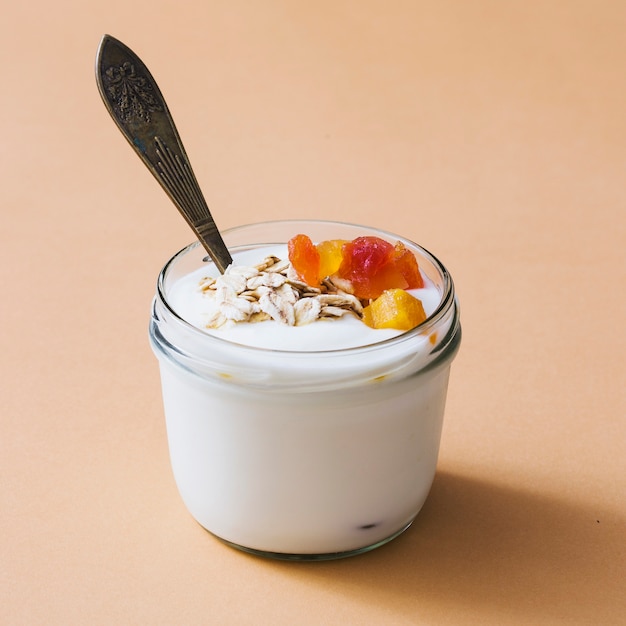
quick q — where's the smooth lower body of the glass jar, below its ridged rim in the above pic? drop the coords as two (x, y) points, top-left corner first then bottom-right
(161, 354), (450, 554)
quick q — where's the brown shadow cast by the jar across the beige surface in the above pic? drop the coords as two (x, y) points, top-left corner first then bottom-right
(273, 472), (626, 624)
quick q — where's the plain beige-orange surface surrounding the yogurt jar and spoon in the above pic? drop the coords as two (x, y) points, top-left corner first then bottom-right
(0, 0), (626, 625)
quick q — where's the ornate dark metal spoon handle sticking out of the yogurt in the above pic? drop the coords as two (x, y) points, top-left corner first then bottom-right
(96, 35), (232, 273)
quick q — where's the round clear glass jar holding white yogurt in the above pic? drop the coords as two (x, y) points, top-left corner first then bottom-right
(150, 220), (461, 560)
